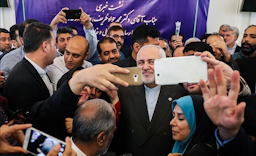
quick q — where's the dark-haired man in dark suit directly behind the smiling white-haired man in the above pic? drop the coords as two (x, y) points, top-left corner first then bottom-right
(114, 25), (160, 67)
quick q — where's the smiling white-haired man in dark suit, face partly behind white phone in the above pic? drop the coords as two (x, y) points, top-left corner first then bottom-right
(116, 45), (187, 156)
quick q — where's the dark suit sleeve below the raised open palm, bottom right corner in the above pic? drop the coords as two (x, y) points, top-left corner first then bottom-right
(217, 128), (256, 156)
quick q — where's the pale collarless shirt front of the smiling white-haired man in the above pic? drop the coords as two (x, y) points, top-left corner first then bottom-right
(144, 85), (161, 121)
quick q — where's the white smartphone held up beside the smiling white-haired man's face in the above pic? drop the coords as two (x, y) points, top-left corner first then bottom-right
(155, 56), (208, 85)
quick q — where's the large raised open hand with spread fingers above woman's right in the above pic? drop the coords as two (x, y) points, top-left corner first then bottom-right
(200, 65), (245, 140)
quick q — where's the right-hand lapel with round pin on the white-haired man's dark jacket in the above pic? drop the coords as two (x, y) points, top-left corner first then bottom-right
(146, 86), (176, 140)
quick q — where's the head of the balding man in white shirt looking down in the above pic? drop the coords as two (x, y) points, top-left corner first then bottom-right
(64, 36), (89, 69)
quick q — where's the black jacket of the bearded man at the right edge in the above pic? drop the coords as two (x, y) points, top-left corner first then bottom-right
(236, 57), (256, 93)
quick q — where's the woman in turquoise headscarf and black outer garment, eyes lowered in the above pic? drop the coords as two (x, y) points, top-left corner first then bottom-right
(170, 95), (216, 156)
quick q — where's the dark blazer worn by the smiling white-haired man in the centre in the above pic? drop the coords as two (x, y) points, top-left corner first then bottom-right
(117, 85), (187, 156)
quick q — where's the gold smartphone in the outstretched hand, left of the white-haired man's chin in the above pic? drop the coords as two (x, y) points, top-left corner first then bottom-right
(113, 67), (142, 86)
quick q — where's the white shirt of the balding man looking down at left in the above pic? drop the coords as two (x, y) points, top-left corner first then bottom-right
(46, 56), (92, 91)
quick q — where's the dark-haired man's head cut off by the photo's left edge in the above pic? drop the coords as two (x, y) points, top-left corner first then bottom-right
(0, 28), (11, 55)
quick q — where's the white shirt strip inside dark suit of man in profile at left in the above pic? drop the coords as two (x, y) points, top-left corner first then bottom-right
(25, 56), (53, 96)
